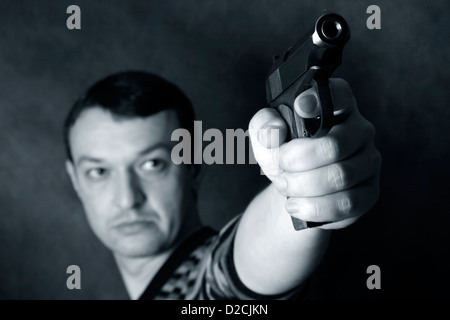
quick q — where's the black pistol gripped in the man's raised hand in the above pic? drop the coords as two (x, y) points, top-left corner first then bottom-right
(266, 13), (350, 230)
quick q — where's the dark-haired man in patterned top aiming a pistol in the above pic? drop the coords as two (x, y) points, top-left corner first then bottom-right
(65, 72), (380, 299)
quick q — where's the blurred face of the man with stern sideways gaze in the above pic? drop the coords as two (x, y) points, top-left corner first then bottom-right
(66, 107), (194, 256)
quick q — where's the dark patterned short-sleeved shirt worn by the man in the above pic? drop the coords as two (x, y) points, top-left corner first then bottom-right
(139, 215), (300, 300)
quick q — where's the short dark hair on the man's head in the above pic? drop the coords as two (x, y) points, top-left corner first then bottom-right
(64, 71), (195, 161)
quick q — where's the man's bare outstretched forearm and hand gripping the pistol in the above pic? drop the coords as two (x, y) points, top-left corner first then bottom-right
(234, 79), (381, 294)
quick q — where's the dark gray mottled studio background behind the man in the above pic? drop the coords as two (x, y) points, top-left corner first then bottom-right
(0, 0), (450, 299)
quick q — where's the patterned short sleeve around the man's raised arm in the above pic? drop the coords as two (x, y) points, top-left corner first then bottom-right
(191, 215), (302, 300)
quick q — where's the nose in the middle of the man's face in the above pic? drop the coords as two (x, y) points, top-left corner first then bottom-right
(114, 171), (146, 210)
